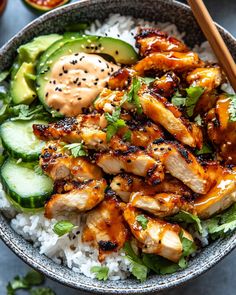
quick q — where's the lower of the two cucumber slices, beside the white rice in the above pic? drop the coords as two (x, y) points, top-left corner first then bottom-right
(1, 158), (53, 209)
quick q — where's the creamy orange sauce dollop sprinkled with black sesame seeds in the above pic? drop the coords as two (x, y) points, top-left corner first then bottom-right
(45, 53), (119, 116)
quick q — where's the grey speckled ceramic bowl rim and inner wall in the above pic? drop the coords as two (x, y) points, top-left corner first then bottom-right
(0, 0), (236, 294)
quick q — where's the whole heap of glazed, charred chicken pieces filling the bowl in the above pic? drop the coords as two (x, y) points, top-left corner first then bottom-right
(33, 28), (236, 262)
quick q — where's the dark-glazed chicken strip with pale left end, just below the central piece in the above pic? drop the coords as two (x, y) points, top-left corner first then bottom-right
(110, 173), (192, 203)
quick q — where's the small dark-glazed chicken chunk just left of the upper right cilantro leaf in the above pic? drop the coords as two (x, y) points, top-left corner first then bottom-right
(152, 72), (180, 98)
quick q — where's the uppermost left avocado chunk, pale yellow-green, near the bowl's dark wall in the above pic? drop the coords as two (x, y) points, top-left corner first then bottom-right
(18, 34), (62, 63)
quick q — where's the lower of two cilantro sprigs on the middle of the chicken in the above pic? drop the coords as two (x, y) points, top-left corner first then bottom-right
(105, 108), (126, 142)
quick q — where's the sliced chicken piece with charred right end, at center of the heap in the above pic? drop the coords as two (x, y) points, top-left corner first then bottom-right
(96, 146), (164, 184)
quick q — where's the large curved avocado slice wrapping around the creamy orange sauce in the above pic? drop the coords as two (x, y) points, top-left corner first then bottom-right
(36, 36), (138, 112)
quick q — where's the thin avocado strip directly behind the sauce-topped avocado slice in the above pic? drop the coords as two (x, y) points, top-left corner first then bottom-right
(36, 33), (81, 74)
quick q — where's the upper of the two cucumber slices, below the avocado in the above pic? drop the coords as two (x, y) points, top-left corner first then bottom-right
(0, 120), (47, 161)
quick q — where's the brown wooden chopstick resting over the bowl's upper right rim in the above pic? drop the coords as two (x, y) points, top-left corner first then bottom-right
(187, 0), (236, 92)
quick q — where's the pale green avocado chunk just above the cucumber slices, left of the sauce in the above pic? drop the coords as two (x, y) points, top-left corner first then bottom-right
(10, 62), (37, 105)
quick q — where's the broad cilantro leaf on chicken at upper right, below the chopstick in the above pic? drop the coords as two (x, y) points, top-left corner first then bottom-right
(171, 86), (205, 117)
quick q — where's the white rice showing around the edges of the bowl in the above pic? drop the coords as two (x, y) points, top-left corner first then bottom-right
(0, 14), (232, 280)
